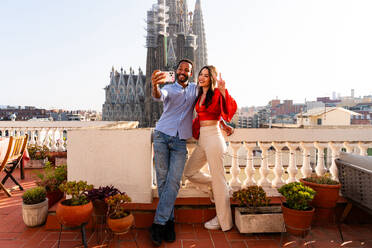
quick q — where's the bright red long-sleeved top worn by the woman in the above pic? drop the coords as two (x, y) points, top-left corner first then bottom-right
(192, 88), (237, 139)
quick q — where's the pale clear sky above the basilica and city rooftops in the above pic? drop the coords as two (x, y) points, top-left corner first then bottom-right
(0, 0), (372, 111)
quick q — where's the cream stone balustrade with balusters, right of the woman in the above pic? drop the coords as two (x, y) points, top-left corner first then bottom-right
(185, 128), (372, 190)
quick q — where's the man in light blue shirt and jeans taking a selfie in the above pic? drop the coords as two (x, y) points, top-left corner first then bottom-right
(150, 59), (197, 246)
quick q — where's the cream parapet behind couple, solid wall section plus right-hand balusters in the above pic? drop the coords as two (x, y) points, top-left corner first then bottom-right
(52, 127), (372, 203)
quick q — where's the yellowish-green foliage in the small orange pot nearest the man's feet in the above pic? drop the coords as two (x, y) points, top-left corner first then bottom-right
(105, 192), (132, 219)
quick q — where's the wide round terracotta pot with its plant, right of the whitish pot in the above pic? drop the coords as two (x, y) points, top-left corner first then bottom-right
(56, 181), (93, 227)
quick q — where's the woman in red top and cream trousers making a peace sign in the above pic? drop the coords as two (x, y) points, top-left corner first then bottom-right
(184, 66), (237, 231)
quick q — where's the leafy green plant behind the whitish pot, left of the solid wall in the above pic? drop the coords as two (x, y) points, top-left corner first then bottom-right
(36, 161), (67, 192)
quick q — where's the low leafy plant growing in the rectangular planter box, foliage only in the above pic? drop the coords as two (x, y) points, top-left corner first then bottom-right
(233, 186), (270, 208)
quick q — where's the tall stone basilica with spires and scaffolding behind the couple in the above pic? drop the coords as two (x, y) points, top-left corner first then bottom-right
(102, 0), (207, 127)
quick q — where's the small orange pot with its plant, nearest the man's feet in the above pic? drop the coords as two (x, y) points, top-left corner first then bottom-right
(105, 192), (134, 234)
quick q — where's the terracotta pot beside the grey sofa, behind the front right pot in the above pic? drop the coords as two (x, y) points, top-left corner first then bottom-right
(300, 179), (341, 208)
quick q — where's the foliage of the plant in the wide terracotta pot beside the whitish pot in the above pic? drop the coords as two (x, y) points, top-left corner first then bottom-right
(59, 181), (93, 206)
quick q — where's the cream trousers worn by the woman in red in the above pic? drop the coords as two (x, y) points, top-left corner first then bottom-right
(184, 126), (233, 231)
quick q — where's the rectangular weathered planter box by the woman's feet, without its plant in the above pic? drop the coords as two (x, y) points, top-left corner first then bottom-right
(235, 206), (285, 233)
